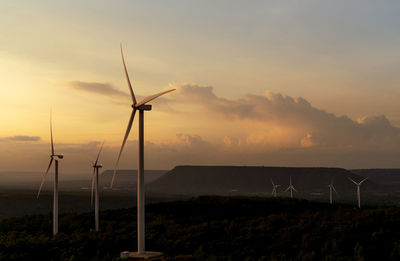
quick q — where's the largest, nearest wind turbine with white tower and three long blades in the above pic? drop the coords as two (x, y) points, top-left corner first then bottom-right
(110, 45), (175, 255)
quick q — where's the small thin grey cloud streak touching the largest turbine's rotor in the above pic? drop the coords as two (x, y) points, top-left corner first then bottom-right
(68, 81), (129, 97)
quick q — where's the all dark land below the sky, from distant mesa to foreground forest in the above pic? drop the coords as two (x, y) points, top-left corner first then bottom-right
(0, 166), (400, 261)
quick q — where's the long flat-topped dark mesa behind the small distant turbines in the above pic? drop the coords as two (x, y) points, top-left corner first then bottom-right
(148, 166), (378, 195)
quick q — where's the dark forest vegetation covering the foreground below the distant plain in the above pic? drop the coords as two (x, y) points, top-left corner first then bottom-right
(0, 197), (400, 260)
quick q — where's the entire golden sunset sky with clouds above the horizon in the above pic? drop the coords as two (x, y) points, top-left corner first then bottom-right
(0, 0), (400, 173)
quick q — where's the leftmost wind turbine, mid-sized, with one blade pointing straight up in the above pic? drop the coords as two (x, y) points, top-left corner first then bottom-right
(36, 113), (64, 236)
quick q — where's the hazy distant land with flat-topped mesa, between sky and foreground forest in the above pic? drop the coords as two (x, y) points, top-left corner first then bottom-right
(0, 166), (400, 219)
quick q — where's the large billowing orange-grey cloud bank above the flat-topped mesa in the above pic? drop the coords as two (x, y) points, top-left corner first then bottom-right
(166, 84), (400, 149)
